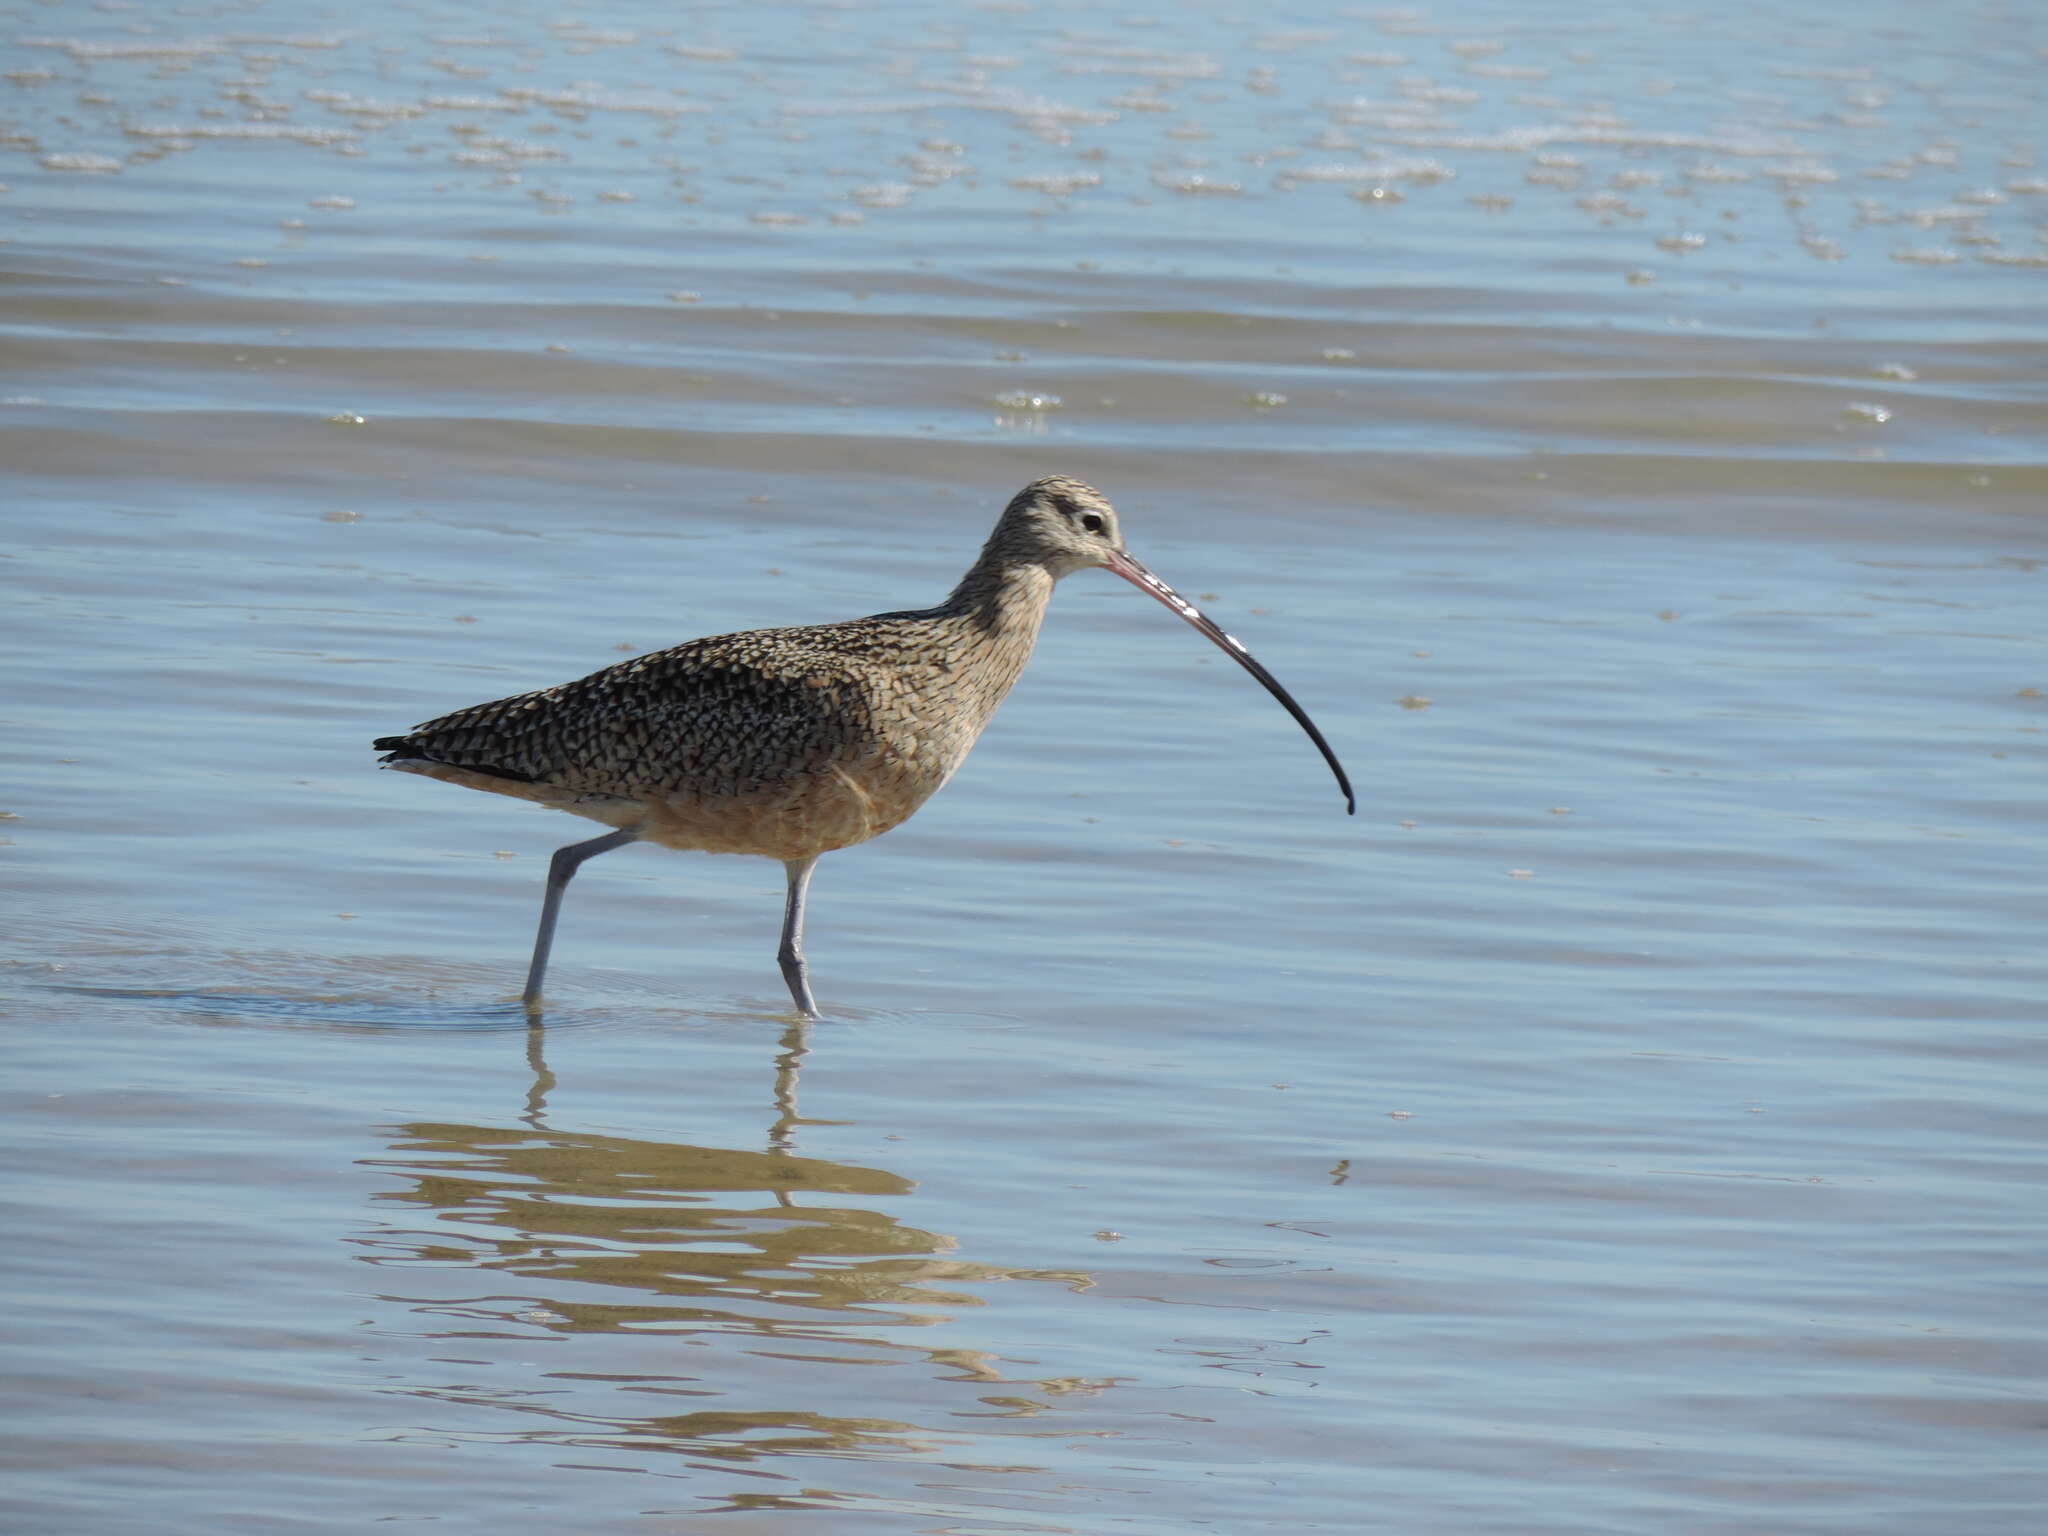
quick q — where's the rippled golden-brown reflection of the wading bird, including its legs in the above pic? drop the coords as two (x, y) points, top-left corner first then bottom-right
(358, 1020), (1114, 1466)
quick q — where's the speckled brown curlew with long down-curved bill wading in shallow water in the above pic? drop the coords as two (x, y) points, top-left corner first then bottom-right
(373, 475), (1358, 1020)
